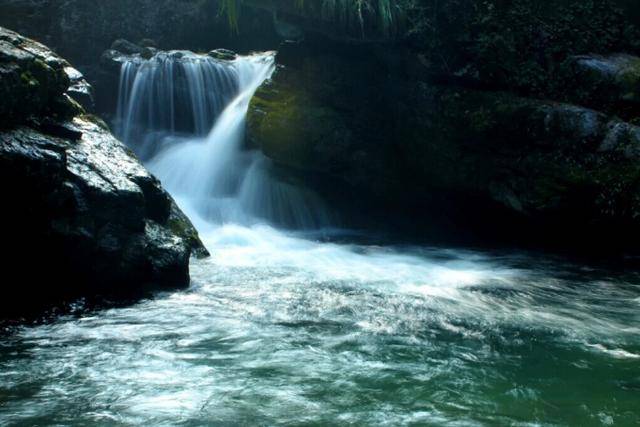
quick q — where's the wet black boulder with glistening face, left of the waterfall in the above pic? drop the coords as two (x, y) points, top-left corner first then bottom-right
(0, 28), (206, 316)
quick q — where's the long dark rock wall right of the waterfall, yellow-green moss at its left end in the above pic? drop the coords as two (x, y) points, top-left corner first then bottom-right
(248, 40), (640, 251)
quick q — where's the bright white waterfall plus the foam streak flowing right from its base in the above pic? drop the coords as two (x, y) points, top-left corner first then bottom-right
(114, 52), (640, 357)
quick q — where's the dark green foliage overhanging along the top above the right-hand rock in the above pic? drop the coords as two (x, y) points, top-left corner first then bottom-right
(220, 0), (640, 105)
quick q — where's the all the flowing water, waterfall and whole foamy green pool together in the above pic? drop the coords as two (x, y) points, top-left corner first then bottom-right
(0, 53), (640, 426)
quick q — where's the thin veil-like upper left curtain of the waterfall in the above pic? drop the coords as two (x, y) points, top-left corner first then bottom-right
(116, 51), (240, 160)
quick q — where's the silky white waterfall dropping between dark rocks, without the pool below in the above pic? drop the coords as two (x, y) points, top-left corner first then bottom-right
(116, 51), (332, 229)
